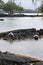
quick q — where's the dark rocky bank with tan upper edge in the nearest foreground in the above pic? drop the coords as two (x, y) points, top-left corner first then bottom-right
(0, 52), (43, 65)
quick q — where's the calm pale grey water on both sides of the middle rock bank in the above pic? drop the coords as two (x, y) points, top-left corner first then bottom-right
(0, 17), (43, 59)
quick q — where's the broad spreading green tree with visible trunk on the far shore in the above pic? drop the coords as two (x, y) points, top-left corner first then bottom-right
(4, 1), (23, 14)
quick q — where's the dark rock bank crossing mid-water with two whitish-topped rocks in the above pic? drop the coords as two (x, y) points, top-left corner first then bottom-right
(0, 28), (43, 40)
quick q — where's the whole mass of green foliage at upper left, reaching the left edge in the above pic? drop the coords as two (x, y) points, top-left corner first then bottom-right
(0, 1), (24, 14)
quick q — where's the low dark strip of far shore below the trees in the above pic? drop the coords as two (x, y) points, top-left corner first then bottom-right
(0, 14), (43, 17)
